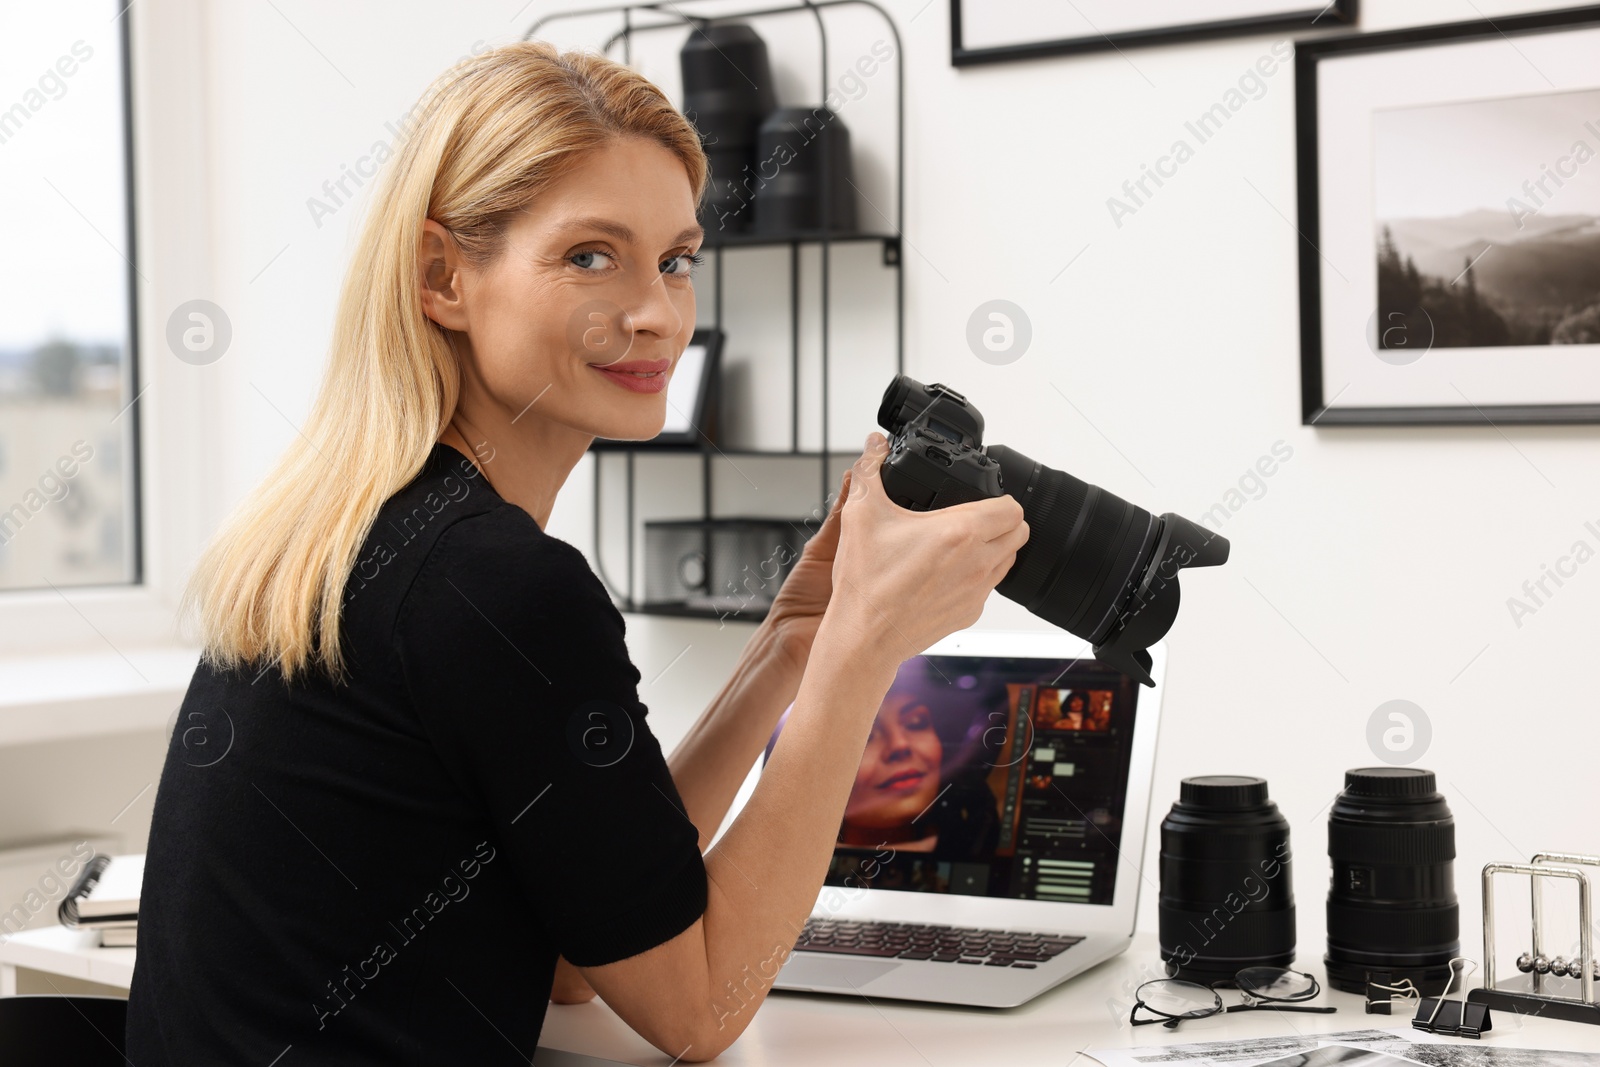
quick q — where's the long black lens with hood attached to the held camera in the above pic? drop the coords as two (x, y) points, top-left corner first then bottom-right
(986, 445), (1229, 681)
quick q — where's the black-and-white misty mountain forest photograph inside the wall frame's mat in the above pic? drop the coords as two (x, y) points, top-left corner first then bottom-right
(1373, 90), (1600, 355)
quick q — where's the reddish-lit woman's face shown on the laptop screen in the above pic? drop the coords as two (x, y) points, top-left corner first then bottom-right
(845, 693), (944, 827)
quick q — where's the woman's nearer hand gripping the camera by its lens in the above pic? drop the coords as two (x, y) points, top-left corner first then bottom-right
(829, 434), (1027, 664)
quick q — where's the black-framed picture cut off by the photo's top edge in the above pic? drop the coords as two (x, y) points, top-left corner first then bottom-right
(950, 0), (1357, 67)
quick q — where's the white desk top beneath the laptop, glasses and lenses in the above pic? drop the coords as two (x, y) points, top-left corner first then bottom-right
(0, 926), (1600, 1067)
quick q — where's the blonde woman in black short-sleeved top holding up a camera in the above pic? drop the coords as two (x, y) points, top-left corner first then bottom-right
(128, 43), (1027, 1067)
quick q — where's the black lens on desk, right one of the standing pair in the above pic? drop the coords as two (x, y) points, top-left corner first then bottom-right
(1326, 766), (1461, 995)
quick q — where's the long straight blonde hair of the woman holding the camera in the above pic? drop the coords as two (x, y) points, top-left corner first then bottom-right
(181, 42), (707, 680)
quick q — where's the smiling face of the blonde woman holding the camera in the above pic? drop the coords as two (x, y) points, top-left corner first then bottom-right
(424, 138), (704, 440)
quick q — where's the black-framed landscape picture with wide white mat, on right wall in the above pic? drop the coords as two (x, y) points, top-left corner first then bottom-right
(1294, 6), (1600, 426)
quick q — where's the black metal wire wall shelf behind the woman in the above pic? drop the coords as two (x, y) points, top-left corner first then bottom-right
(523, 0), (906, 621)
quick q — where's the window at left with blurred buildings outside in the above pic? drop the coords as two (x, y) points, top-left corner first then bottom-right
(0, 0), (139, 590)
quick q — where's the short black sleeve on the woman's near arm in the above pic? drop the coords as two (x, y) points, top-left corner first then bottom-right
(395, 506), (706, 966)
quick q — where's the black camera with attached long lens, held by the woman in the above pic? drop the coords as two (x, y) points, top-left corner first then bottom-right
(878, 374), (1229, 685)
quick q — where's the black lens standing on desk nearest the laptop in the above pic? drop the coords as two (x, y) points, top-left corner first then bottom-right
(1158, 774), (1294, 982)
